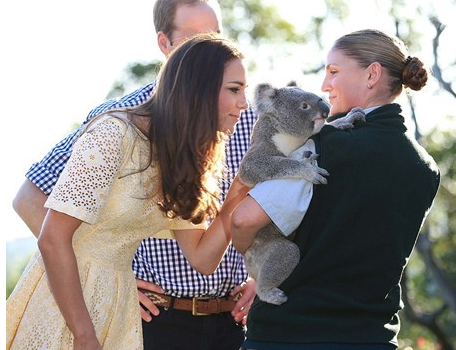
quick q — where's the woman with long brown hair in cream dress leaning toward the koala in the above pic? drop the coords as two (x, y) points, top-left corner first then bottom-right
(6, 35), (247, 350)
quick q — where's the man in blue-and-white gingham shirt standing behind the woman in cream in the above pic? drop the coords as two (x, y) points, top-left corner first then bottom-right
(13, 0), (256, 349)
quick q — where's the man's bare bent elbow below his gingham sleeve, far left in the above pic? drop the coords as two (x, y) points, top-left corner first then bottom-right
(13, 179), (47, 237)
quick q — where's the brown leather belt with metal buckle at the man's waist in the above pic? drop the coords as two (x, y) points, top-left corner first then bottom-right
(140, 289), (240, 316)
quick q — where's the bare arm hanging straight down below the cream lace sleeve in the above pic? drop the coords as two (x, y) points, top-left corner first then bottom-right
(38, 209), (101, 349)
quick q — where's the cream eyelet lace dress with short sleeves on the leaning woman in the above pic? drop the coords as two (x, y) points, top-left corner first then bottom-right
(6, 115), (203, 350)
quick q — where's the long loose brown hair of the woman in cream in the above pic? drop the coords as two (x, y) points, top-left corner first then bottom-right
(129, 34), (243, 223)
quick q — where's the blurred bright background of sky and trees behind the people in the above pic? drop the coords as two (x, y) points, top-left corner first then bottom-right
(0, 0), (456, 350)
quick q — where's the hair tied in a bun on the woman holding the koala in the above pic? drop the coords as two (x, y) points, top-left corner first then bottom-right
(333, 29), (427, 96)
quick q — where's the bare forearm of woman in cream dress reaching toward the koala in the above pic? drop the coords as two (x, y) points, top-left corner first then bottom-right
(174, 177), (250, 275)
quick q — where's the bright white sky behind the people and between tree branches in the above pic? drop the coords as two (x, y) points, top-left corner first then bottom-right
(0, 0), (456, 247)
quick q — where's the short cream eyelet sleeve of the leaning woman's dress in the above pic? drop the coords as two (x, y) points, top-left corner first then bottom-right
(45, 116), (127, 224)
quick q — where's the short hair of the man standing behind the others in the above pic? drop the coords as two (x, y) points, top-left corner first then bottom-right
(154, 0), (220, 40)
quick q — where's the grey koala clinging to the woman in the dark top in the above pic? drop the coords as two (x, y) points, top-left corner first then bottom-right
(238, 84), (364, 305)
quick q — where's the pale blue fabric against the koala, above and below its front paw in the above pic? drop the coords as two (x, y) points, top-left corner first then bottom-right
(249, 140), (315, 236)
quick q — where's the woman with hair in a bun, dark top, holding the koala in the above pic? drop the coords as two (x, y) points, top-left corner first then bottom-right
(231, 30), (440, 350)
